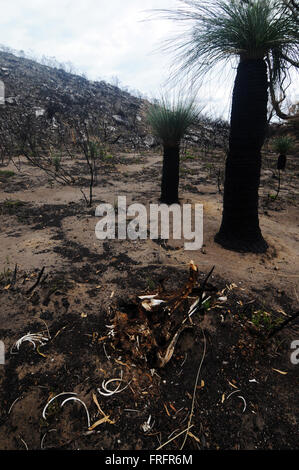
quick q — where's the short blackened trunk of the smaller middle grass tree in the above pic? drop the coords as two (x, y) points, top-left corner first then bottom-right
(160, 145), (180, 205)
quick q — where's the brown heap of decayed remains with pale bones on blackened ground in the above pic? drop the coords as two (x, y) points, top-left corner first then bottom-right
(108, 261), (211, 368)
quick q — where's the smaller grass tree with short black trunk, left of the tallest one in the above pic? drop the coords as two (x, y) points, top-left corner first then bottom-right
(148, 97), (198, 204)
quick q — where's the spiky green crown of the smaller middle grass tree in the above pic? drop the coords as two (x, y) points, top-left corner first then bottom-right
(147, 96), (199, 147)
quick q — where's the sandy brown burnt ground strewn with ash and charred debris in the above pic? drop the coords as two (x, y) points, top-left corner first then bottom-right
(0, 145), (299, 450)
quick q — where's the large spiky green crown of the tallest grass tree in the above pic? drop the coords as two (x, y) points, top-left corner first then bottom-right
(160, 0), (299, 80)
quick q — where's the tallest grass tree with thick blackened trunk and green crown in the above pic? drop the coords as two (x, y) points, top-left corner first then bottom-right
(157, 0), (298, 253)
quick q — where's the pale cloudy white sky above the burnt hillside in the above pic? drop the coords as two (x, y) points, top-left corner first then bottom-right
(0, 0), (299, 119)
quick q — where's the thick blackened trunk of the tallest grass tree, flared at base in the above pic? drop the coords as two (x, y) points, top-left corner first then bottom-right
(215, 59), (268, 253)
